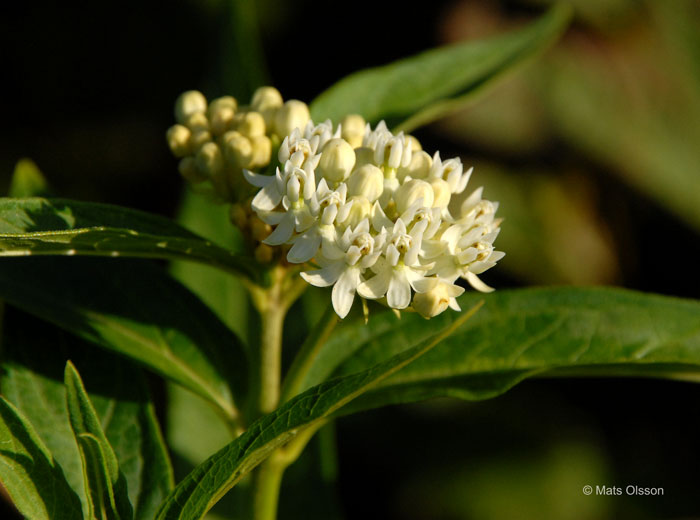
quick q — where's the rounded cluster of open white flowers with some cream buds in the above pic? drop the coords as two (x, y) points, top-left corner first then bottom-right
(244, 116), (504, 318)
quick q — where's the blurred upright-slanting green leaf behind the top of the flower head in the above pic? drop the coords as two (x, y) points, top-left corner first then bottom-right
(311, 6), (570, 130)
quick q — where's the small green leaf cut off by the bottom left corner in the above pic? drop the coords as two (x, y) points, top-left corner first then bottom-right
(0, 396), (83, 520)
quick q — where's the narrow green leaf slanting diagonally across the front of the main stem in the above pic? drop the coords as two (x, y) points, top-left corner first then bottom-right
(157, 306), (478, 520)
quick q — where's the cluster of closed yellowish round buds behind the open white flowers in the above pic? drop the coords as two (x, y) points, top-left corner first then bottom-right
(167, 87), (310, 202)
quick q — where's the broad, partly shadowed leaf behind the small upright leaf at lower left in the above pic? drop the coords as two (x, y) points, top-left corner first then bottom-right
(0, 307), (173, 520)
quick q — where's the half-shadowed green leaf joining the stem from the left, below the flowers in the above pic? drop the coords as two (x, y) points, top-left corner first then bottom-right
(0, 258), (247, 420)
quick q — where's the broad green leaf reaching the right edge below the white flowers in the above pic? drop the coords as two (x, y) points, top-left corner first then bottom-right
(306, 288), (700, 412)
